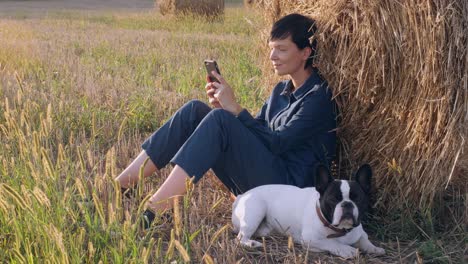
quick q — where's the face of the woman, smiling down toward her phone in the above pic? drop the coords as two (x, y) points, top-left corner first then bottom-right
(268, 36), (310, 76)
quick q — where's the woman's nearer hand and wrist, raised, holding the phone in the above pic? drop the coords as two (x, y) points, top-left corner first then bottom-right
(212, 71), (242, 116)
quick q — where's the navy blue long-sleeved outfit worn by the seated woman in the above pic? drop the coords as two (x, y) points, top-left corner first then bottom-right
(142, 69), (336, 195)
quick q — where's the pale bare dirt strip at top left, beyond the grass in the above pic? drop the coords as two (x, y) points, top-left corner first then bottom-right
(0, 0), (155, 17)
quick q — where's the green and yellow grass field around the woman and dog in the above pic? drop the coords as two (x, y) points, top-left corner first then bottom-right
(0, 7), (466, 263)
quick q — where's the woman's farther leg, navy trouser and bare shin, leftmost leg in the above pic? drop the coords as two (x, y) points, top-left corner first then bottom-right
(116, 100), (211, 188)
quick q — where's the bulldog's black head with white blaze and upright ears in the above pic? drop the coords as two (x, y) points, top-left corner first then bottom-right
(315, 164), (372, 229)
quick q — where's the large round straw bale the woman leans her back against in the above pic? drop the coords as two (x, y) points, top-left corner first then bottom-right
(256, 0), (468, 222)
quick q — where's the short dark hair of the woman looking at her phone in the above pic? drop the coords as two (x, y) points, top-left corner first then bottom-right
(269, 14), (317, 68)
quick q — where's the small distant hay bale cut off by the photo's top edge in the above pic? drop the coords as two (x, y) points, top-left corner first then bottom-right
(157, 0), (224, 17)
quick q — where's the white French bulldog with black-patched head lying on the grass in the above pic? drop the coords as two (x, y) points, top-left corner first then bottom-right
(232, 164), (385, 258)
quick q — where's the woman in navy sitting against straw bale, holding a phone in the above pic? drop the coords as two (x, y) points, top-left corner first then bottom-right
(116, 14), (336, 227)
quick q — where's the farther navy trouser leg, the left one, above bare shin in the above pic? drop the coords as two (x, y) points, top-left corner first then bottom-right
(141, 100), (211, 169)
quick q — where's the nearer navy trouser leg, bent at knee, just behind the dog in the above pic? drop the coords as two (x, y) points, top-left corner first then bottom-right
(171, 109), (290, 195)
